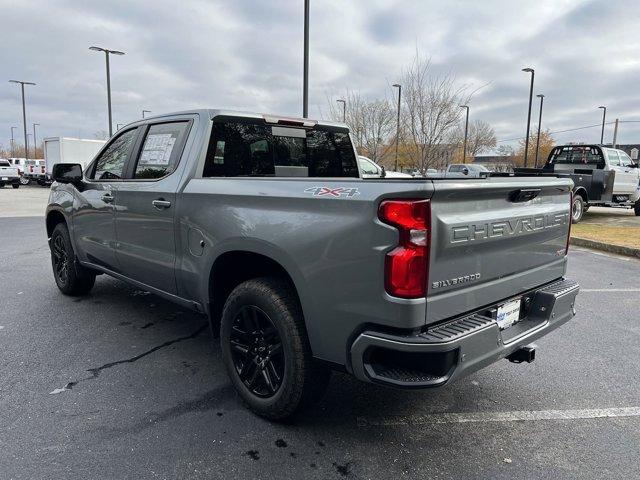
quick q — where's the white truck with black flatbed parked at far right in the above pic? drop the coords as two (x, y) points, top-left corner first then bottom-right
(514, 145), (640, 223)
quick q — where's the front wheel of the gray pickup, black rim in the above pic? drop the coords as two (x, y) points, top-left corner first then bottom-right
(50, 223), (96, 296)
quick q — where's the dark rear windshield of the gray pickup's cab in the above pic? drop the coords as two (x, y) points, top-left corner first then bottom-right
(203, 121), (358, 178)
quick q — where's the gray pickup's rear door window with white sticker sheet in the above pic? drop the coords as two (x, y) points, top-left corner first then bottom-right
(133, 122), (187, 179)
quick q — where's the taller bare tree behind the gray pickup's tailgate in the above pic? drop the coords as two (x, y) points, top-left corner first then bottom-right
(402, 52), (469, 171)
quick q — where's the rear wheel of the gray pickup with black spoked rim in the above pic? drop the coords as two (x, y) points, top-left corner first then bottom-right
(220, 277), (331, 420)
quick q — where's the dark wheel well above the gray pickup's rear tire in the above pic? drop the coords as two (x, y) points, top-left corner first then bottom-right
(209, 251), (299, 331)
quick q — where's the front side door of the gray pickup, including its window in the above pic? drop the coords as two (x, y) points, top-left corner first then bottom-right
(73, 128), (137, 272)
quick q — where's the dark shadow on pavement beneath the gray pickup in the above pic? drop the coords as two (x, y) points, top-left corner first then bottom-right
(68, 277), (500, 436)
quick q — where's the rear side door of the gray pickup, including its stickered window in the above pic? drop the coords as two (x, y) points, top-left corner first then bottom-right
(116, 121), (189, 294)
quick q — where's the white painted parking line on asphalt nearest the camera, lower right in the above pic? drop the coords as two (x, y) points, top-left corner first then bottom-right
(357, 407), (640, 427)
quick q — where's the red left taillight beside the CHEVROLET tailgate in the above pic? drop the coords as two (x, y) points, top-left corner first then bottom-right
(378, 200), (431, 298)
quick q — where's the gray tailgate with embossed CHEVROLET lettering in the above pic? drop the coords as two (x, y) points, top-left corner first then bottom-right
(426, 177), (572, 323)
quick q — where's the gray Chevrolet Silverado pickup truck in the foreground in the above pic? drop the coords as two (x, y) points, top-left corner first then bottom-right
(46, 110), (579, 420)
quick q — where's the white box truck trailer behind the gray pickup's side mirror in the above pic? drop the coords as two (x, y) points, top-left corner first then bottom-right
(37, 137), (105, 186)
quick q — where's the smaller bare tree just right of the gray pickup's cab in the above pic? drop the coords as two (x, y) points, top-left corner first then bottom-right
(329, 92), (395, 162)
